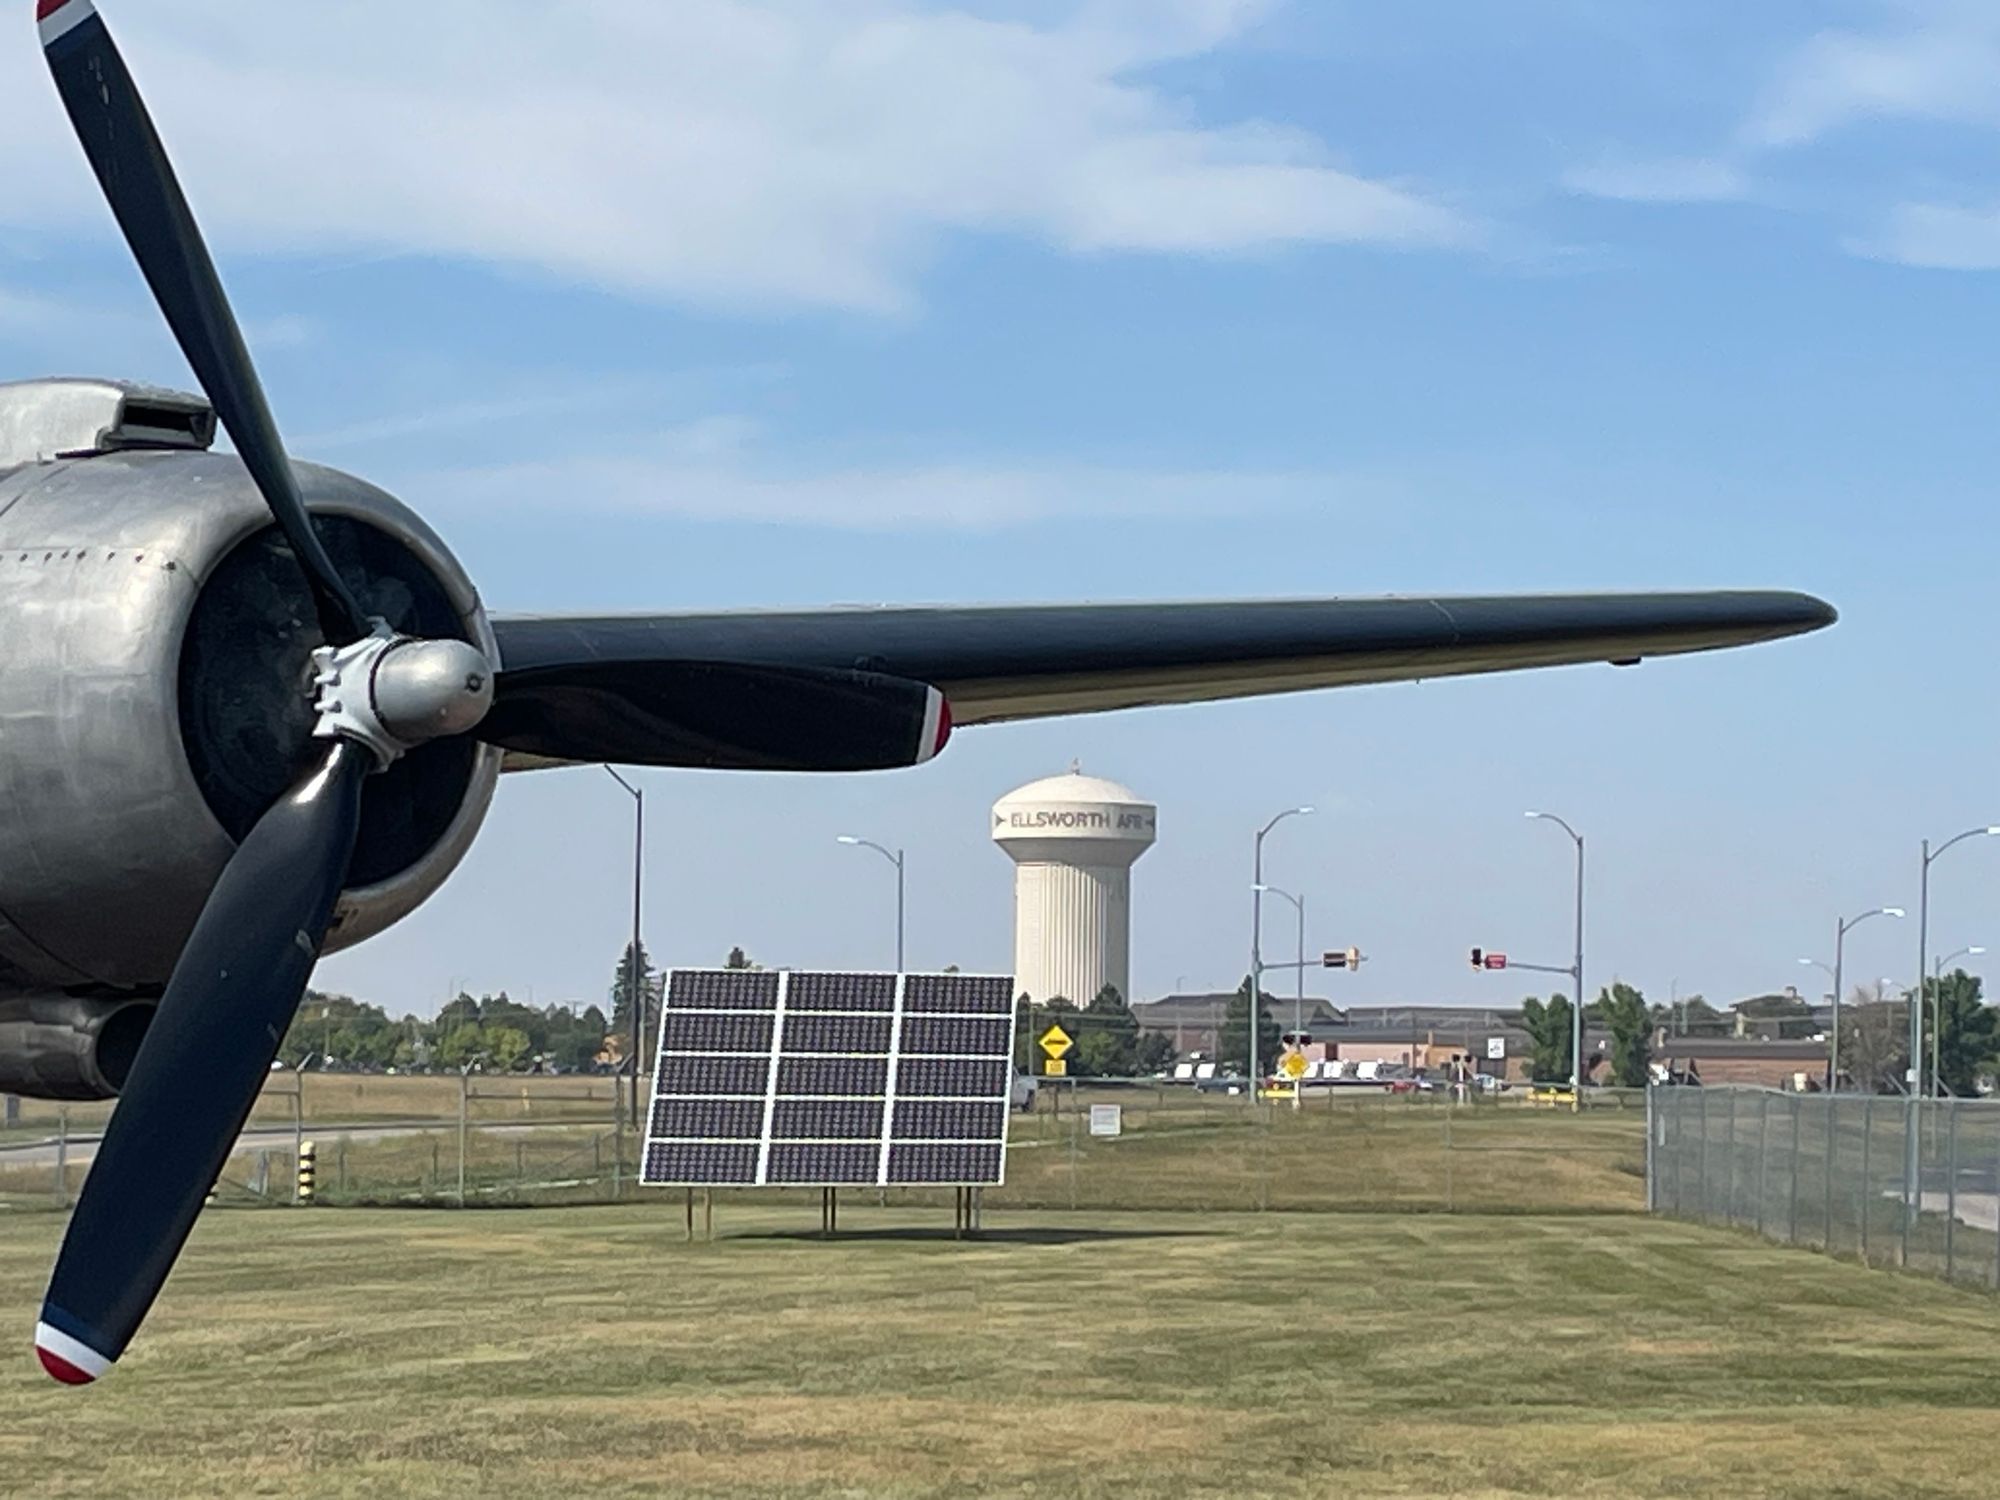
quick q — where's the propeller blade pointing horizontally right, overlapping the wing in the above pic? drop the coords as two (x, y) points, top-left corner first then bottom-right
(478, 660), (952, 770)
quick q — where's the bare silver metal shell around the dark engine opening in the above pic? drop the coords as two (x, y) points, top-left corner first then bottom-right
(0, 420), (500, 1000)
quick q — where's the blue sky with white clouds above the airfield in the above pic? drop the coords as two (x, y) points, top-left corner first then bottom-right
(0, 0), (2000, 1010)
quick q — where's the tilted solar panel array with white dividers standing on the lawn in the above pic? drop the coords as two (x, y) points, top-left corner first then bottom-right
(640, 968), (1014, 1186)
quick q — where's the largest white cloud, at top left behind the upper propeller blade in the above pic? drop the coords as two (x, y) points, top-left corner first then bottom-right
(0, 0), (1476, 310)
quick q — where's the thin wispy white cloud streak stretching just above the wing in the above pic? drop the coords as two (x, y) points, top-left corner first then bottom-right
(410, 416), (1344, 530)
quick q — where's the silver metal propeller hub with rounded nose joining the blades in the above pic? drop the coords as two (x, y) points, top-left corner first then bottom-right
(312, 620), (494, 766)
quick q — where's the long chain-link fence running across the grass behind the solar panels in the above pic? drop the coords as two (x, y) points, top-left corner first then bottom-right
(0, 1074), (1646, 1214)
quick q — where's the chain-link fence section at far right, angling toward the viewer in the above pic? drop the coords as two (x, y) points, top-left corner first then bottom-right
(1646, 1086), (2000, 1290)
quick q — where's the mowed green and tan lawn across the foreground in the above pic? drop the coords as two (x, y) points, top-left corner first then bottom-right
(0, 1200), (2000, 1500)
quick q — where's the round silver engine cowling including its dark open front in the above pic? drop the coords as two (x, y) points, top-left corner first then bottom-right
(0, 440), (500, 996)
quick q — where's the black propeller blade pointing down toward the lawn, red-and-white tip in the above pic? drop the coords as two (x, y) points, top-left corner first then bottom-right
(34, 740), (374, 1384)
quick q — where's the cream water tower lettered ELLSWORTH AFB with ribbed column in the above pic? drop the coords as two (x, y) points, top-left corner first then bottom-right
(992, 768), (1158, 1006)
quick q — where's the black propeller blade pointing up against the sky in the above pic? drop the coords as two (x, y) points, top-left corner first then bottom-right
(36, 0), (368, 646)
